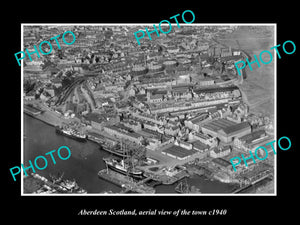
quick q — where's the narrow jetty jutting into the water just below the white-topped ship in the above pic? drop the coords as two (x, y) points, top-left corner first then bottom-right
(98, 169), (155, 194)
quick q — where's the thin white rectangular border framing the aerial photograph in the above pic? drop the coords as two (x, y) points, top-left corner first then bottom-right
(21, 23), (277, 197)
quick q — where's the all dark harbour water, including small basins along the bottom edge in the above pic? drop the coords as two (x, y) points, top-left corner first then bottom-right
(24, 114), (238, 194)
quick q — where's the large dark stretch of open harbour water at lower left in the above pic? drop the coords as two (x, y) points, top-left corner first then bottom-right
(24, 114), (120, 193)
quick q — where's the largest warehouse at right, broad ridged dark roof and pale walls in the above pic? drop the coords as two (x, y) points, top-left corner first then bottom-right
(202, 119), (251, 143)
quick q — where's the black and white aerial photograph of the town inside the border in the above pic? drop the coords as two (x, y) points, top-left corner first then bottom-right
(19, 23), (276, 195)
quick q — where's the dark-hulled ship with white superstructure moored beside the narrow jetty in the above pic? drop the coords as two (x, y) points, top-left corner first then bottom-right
(103, 157), (144, 179)
